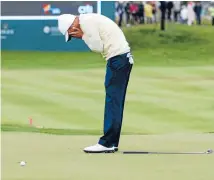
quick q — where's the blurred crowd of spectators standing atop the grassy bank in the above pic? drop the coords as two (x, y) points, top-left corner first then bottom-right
(115, 1), (214, 27)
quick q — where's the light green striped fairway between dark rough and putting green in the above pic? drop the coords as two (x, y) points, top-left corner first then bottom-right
(2, 66), (214, 134)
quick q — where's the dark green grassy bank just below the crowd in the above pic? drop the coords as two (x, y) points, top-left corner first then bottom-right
(124, 24), (214, 50)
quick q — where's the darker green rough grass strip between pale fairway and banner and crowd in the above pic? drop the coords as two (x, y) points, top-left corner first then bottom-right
(2, 25), (214, 69)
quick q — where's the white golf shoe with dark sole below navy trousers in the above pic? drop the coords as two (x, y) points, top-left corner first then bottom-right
(84, 144), (115, 153)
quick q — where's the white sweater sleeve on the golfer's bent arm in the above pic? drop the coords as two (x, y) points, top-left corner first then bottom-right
(82, 31), (104, 53)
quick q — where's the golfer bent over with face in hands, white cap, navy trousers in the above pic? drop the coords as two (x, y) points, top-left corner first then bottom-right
(58, 13), (134, 153)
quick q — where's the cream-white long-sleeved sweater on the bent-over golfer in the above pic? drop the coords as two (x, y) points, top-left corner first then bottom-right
(80, 13), (130, 60)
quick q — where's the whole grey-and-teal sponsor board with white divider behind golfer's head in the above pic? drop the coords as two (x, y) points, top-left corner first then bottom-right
(1, 1), (114, 51)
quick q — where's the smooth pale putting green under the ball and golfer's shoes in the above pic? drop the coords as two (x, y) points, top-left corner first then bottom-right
(2, 132), (214, 180)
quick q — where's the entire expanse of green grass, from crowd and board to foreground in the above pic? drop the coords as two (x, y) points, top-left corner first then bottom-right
(1, 25), (214, 180)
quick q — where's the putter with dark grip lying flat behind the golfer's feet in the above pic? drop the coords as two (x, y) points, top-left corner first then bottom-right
(123, 149), (213, 154)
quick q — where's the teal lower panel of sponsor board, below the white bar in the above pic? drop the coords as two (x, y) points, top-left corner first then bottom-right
(1, 20), (89, 51)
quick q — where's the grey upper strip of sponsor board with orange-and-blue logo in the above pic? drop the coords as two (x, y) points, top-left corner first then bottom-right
(1, 1), (98, 18)
